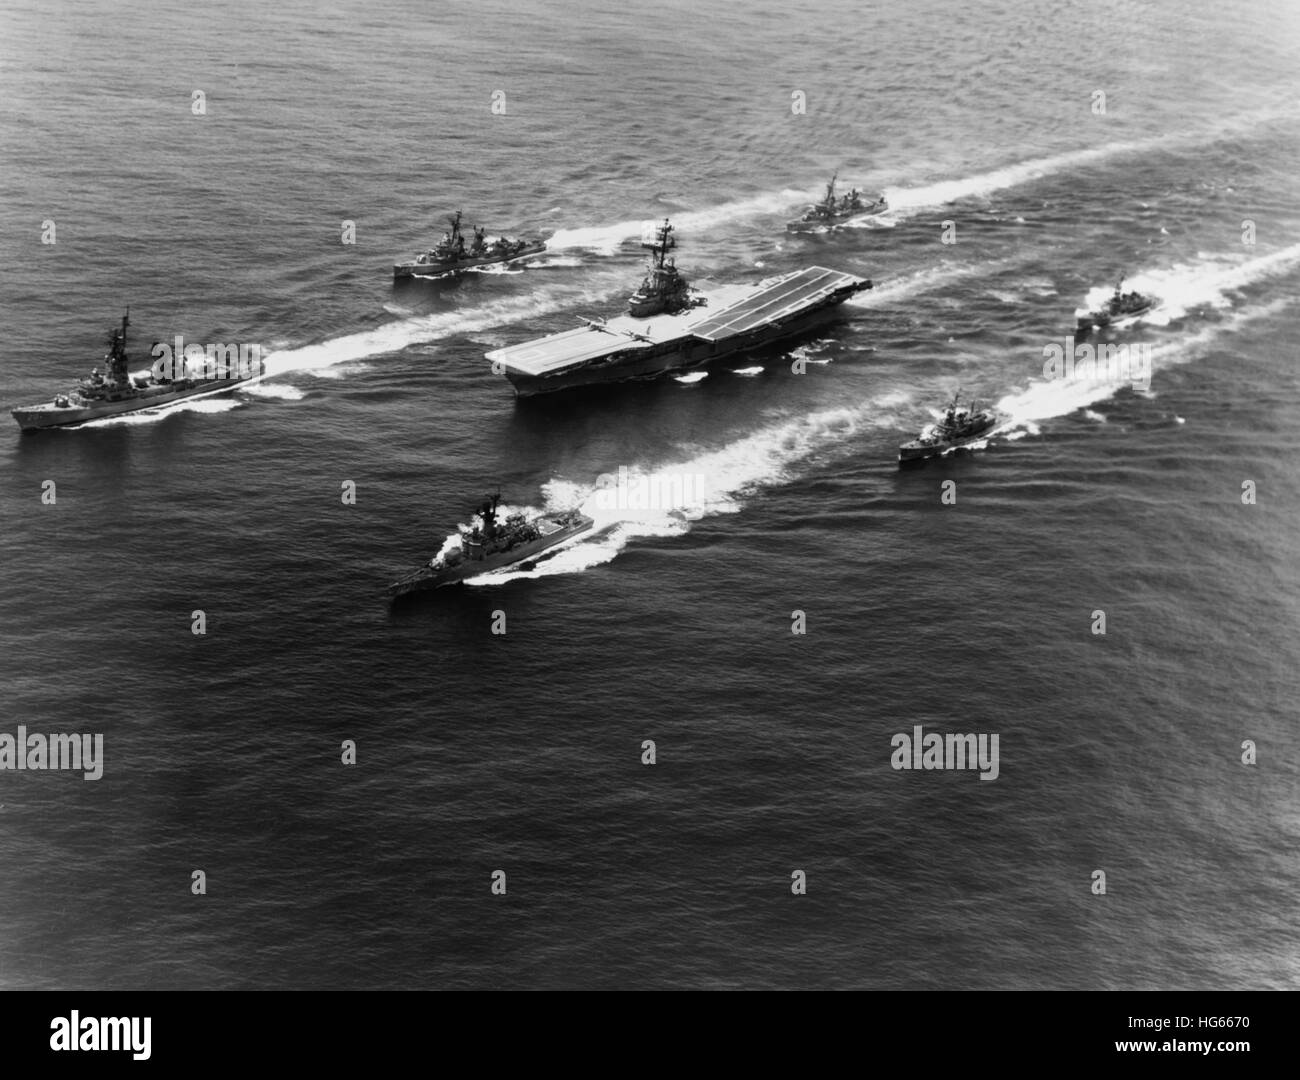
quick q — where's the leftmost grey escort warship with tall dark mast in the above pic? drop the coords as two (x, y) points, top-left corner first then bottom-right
(10, 312), (261, 431)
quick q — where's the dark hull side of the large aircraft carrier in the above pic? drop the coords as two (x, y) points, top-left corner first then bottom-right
(503, 290), (857, 398)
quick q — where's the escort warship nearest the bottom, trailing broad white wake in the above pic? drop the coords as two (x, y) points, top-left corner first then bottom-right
(389, 493), (594, 599)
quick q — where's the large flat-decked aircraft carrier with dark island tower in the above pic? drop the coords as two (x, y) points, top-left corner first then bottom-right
(486, 218), (871, 398)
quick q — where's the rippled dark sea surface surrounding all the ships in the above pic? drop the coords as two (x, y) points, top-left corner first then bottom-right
(0, 0), (1300, 989)
